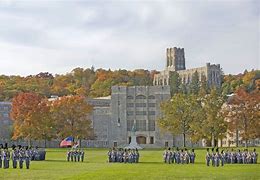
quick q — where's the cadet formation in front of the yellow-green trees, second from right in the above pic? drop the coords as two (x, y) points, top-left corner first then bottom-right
(163, 148), (196, 164)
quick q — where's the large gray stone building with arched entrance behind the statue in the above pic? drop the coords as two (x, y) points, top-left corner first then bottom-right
(88, 86), (173, 147)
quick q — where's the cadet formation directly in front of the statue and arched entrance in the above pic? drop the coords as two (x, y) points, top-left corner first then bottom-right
(107, 148), (140, 163)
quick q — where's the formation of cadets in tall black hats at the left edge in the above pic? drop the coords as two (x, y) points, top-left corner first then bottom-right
(0, 144), (38, 169)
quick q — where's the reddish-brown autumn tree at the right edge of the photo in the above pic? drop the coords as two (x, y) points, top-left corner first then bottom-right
(223, 88), (260, 147)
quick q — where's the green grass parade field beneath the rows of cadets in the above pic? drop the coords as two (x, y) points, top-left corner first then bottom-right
(0, 148), (260, 180)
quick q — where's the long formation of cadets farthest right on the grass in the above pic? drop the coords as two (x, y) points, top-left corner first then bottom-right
(206, 148), (258, 167)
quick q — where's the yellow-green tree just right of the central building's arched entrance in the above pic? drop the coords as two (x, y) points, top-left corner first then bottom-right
(158, 94), (202, 147)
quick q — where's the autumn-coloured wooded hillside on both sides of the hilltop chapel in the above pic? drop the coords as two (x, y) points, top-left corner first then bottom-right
(0, 67), (260, 101)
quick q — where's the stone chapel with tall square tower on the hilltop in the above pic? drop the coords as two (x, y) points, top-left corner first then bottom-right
(153, 47), (222, 87)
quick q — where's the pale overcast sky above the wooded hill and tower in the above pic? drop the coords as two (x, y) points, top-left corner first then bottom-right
(0, 0), (260, 76)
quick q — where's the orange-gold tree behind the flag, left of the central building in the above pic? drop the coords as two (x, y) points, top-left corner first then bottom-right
(51, 96), (93, 143)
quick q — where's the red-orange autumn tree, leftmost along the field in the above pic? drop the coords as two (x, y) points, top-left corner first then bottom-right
(11, 93), (41, 144)
